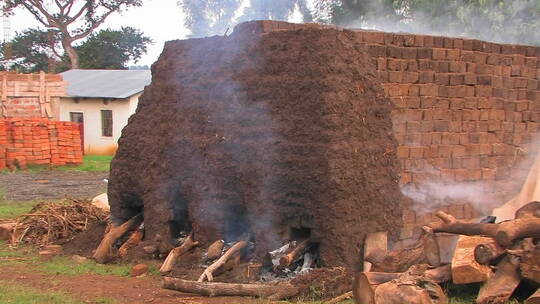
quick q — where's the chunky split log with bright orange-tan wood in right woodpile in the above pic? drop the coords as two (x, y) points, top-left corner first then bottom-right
(452, 235), (492, 284)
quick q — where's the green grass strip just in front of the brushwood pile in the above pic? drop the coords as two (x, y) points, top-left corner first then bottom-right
(38, 256), (131, 277)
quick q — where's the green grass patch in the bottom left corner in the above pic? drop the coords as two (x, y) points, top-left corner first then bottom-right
(0, 281), (84, 304)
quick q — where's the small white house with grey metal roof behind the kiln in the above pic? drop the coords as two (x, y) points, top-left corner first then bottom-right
(59, 69), (151, 154)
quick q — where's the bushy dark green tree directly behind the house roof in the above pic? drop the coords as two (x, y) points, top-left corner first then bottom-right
(75, 27), (152, 69)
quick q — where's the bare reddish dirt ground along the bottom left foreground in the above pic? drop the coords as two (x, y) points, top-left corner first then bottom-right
(0, 265), (265, 304)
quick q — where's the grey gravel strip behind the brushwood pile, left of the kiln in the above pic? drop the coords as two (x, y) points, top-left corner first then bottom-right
(0, 171), (109, 201)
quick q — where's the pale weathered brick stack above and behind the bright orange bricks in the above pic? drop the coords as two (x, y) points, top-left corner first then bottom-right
(0, 72), (66, 119)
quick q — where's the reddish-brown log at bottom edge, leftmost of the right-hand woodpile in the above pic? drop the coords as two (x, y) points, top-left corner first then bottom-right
(352, 272), (400, 304)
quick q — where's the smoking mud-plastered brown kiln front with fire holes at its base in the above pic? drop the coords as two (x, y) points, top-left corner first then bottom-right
(108, 23), (401, 267)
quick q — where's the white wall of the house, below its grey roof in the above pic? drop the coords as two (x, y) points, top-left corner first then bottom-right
(59, 93), (141, 155)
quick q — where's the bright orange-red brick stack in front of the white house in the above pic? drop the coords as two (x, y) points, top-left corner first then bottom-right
(0, 118), (83, 170)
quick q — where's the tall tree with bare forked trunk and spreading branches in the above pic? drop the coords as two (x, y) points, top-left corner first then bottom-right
(4, 0), (142, 68)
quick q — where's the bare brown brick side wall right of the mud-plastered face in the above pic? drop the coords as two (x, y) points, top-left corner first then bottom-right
(240, 21), (540, 238)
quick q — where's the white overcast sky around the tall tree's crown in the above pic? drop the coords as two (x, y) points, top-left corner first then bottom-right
(7, 0), (189, 66)
